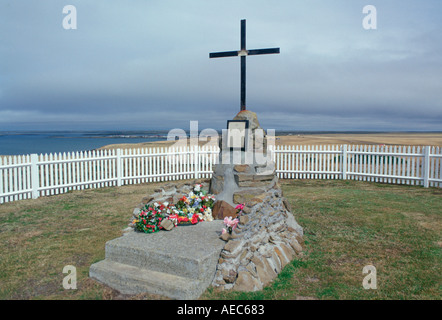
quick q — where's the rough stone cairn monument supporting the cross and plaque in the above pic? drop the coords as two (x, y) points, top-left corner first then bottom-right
(129, 110), (303, 291)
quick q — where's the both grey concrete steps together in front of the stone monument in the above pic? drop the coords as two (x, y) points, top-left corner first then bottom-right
(89, 220), (225, 299)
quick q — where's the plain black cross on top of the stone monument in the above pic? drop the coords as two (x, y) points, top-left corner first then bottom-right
(209, 19), (279, 111)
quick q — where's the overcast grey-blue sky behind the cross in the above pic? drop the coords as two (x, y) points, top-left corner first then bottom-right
(0, 0), (442, 131)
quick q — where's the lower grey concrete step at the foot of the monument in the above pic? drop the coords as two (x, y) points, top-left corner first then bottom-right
(89, 259), (211, 300)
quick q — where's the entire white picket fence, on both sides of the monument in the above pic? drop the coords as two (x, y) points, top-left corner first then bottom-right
(0, 145), (442, 203)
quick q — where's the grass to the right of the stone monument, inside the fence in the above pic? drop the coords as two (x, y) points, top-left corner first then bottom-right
(204, 180), (442, 300)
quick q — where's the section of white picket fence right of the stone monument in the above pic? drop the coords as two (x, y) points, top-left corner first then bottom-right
(274, 145), (442, 188)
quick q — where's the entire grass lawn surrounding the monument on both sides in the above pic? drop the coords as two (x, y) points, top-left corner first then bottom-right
(0, 180), (442, 299)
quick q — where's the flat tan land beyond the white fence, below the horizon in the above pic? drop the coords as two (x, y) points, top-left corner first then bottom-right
(100, 133), (442, 149)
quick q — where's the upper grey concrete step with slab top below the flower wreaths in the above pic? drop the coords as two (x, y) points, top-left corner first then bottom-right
(105, 220), (225, 280)
